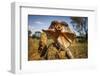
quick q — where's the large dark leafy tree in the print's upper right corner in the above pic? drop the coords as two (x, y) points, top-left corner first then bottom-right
(71, 17), (88, 38)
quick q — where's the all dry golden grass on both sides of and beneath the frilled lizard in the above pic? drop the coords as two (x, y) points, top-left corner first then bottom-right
(28, 37), (88, 61)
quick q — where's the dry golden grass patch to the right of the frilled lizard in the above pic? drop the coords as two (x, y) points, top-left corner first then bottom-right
(70, 42), (88, 58)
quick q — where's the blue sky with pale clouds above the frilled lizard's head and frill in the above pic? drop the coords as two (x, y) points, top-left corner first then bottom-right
(28, 15), (75, 34)
